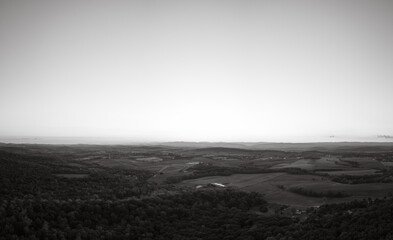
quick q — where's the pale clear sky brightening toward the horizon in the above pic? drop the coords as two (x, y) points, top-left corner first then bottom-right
(0, 0), (393, 142)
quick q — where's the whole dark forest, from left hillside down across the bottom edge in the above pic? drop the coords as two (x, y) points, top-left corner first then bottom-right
(0, 146), (393, 240)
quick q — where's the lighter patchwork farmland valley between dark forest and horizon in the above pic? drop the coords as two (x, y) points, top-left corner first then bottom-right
(1, 144), (393, 208)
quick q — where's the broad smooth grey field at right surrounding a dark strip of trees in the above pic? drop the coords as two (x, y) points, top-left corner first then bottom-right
(182, 173), (393, 208)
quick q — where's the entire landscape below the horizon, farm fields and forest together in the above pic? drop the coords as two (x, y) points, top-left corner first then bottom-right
(0, 144), (393, 240)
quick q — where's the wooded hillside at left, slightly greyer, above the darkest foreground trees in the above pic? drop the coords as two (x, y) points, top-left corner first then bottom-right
(0, 151), (156, 200)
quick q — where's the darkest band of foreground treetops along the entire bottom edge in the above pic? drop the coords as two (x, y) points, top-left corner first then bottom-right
(0, 190), (393, 240)
